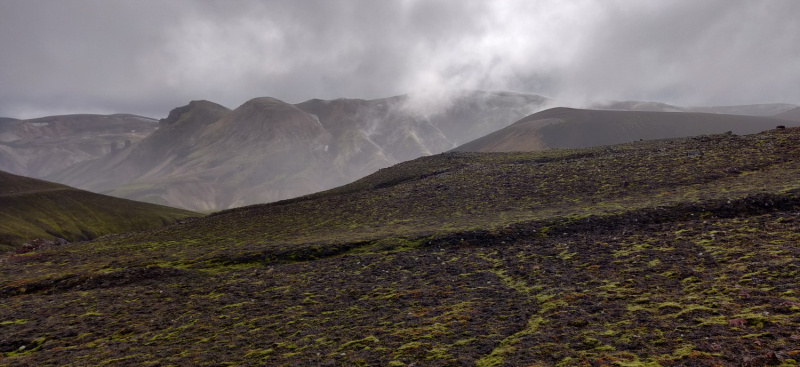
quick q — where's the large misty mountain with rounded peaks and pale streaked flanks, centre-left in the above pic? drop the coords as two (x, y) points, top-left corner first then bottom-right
(47, 91), (548, 210)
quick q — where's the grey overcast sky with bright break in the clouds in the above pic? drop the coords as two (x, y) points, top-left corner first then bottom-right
(0, 0), (800, 118)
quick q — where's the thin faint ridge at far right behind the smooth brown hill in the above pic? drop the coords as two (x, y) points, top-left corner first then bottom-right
(589, 101), (798, 117)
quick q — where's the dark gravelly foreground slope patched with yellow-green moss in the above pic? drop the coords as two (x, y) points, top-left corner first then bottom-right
(0, 129), (800, 366)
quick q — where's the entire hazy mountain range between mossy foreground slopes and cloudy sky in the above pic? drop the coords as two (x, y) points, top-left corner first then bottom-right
(0, 91), (797, 212)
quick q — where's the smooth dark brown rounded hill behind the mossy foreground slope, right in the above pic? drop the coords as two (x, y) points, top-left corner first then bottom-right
(453, 108), (800, 152)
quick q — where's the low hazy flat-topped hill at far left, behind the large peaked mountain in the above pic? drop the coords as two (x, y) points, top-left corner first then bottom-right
(0, 114), (158, 178)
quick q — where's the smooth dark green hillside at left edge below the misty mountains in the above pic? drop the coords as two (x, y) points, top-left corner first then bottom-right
(0, 171), (197, 250)
